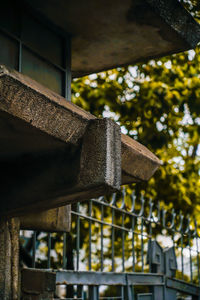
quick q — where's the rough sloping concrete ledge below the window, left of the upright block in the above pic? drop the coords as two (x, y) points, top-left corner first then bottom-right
(0, 66), (95, 154)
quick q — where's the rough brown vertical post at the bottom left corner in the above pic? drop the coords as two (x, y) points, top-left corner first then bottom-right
(0, 218), (19, 300)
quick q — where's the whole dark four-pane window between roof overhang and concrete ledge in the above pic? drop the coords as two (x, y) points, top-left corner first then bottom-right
(0, 0), (70, 97)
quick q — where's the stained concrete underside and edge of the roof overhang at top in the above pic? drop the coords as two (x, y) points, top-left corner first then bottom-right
(26, 0), (200, 77)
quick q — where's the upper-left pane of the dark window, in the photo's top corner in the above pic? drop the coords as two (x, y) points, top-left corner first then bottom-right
(0, 0), (20, 36)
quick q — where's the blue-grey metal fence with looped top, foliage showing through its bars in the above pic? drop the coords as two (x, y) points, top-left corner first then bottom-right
(21, 190), (200, 300)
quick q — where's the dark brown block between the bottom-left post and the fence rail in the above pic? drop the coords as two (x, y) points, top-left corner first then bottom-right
(21, 269), (56, 300)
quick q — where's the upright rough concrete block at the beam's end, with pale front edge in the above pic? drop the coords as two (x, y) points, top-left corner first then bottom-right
(79, 119), (121, 189)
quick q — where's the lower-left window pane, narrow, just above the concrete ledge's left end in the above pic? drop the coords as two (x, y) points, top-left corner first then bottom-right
(0, 33), (18, 69)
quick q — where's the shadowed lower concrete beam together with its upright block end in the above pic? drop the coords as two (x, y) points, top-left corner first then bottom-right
(0, 115), (121, 215)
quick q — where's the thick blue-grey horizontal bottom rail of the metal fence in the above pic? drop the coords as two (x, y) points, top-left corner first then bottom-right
(22, 269), (200, 296)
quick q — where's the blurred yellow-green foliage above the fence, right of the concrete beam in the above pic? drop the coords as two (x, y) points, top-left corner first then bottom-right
(72, 48), (200, 219)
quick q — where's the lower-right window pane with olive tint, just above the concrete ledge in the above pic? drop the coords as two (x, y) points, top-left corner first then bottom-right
(22, 49), (62, 95)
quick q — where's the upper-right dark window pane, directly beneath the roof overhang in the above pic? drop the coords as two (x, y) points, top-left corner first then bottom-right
(22, 16), (62, 66)
